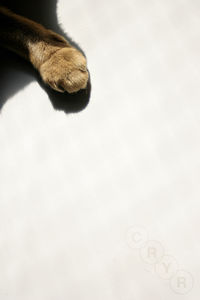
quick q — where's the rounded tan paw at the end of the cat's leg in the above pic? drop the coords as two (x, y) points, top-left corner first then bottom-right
(39, 47), (89, 93)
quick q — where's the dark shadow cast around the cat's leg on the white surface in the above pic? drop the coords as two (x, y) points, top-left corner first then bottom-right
(0, 0), (91, 113)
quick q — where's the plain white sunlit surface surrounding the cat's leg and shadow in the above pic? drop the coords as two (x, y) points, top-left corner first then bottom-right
(0, 0), (200, 300)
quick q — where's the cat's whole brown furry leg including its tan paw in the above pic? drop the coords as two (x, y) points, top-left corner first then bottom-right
(0, 5), (88, 93)
